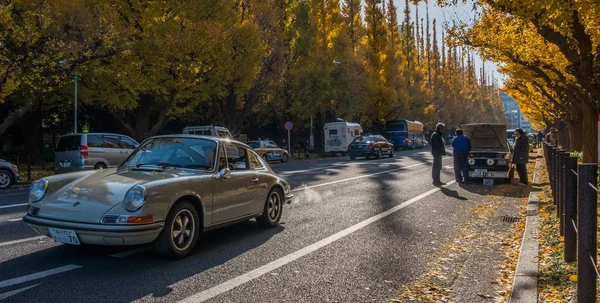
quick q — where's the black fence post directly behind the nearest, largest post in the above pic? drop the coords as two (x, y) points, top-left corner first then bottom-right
(563, 157), (577, 262)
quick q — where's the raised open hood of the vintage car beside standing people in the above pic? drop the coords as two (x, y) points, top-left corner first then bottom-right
(463, 124), (510, 152)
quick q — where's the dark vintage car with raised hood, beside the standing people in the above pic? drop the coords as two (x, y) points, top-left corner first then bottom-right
(463, 124), (514, 182)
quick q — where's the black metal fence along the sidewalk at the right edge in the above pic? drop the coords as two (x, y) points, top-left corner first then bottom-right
(544, 144), (600, 303)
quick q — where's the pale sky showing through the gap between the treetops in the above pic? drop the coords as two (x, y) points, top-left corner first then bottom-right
(394, 0), (504, 86)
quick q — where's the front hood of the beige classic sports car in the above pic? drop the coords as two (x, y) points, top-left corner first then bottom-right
(32, 169), (210, 223)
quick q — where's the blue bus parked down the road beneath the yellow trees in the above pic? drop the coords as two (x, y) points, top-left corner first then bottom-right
(385, 119), (427, 149)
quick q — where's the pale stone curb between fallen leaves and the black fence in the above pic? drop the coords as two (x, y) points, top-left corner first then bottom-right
(508, 150), (543, 303)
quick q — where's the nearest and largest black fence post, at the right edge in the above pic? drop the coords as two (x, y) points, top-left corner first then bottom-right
(577, 164), (598, 303)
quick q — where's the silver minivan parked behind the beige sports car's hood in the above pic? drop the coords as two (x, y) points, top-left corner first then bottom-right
(54, 133), (138, 174)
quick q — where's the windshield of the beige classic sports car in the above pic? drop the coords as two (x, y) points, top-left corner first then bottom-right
(122, 138), (217, 170)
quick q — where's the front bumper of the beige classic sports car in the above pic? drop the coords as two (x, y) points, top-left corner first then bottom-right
(23, 215), (164, 245)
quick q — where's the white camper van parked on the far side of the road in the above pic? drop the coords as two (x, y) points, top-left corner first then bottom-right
(324, 122), (362, 155)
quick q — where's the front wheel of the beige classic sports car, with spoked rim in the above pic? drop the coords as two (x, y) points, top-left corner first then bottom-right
(154, 201), (200, 259)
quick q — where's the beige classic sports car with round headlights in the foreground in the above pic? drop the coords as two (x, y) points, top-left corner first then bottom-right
(23, 135), (293, 258)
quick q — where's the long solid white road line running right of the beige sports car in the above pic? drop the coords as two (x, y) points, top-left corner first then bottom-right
(178, 181), (456, 303)
